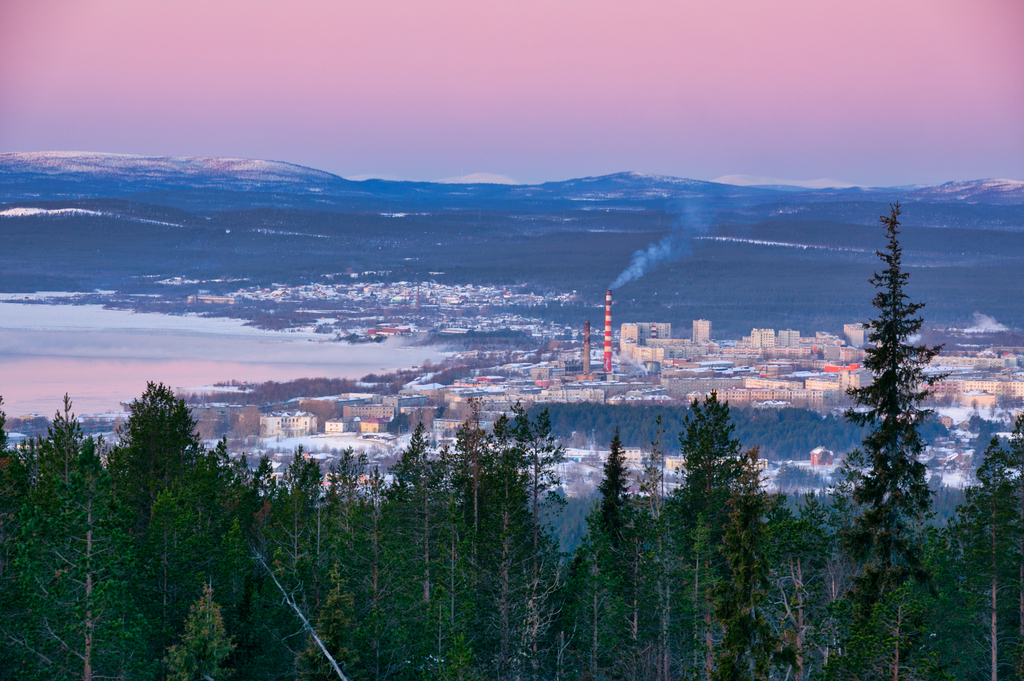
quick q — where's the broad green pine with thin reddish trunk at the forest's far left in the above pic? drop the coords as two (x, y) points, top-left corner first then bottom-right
(9, 413), (152, 681)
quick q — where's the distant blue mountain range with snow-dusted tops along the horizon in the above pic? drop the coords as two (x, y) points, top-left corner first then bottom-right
(0, 152), (1024, 208)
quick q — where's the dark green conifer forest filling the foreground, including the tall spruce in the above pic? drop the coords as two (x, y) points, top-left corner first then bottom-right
(6, 205), (1024, 681)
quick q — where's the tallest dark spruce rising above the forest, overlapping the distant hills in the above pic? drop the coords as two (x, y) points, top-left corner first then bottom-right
(847, 204), (940, 610)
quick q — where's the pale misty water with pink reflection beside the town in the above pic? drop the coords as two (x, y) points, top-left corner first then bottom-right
(0, 301), (443, 417)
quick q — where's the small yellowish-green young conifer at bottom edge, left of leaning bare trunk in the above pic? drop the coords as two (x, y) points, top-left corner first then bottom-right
(167, 585), (234, 681)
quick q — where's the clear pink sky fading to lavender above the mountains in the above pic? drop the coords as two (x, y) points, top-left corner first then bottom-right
(0, 0), (1024, 185)
